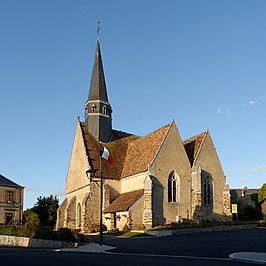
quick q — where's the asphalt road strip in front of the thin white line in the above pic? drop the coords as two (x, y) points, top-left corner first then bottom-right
(0, 248), (242, 266)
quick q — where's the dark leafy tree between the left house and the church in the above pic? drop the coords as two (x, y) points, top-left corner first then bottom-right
(32, 195), (59, 226)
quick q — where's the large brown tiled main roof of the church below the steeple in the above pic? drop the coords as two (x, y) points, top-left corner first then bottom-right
(80, 122), (170, 180)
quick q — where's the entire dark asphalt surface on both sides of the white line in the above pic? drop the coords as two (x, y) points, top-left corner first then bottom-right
(0, 228), (266, 266)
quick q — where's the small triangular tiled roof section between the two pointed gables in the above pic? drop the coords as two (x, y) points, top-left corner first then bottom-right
(183, 130), (208, 166)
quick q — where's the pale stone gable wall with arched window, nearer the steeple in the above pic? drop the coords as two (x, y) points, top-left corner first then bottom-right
(150, 123), (191, 225)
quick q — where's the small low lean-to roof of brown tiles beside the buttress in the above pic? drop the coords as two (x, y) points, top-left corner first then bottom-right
(104, 189), (144, 213)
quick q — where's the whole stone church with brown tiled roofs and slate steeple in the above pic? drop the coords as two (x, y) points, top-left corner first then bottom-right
(57, 39), (231, 230)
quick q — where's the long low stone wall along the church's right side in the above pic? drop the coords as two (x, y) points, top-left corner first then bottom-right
(145, 224), (258, 237)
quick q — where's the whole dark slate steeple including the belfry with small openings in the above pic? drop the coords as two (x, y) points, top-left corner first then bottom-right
(84, 36), (112, 142)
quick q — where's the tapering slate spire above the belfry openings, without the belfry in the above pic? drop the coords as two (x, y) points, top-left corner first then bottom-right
(88, 38), (108, 102)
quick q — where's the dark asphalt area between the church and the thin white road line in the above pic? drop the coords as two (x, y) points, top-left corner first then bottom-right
(93, 227), (266, 258)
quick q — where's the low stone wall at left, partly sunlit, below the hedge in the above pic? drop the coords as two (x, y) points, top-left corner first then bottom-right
(0, 235), (78, 249)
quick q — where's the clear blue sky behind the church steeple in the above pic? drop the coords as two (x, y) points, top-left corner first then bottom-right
(0, 0), (266, 208)
